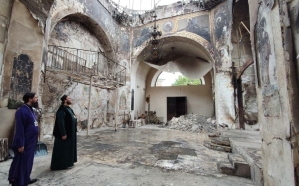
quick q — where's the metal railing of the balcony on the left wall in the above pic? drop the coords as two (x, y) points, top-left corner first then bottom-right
(46, 45), (126, 85)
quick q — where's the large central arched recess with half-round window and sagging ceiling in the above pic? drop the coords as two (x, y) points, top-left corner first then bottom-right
(134, 37), (214, 122)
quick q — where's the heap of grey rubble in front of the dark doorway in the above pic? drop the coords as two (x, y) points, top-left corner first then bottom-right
(165, 114), (217, 133)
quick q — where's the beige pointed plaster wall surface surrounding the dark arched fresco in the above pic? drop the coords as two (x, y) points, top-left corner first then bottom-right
(2, 1), (43, 99)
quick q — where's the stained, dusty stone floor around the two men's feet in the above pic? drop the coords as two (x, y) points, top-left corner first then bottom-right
(0, 125), (252, 186)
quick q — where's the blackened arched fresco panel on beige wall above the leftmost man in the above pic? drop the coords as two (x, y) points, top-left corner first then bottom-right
(8, 54), (33, 109)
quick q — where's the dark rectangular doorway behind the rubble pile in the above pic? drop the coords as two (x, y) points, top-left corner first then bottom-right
(167, 97), (187, 121)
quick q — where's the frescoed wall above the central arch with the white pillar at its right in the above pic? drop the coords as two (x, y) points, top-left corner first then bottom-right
(133, 0), (236, 128)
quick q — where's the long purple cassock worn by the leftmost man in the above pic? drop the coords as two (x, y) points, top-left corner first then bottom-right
(8, 104), (38, 186)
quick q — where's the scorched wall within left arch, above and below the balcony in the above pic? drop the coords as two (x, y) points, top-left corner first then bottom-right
(43, 20), (116, 135)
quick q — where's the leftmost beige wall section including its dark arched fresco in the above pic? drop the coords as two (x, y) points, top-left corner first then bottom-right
(0, 0), (43, 143)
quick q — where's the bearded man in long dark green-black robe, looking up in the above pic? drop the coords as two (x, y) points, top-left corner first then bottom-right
(50, 95), (77, 170)
